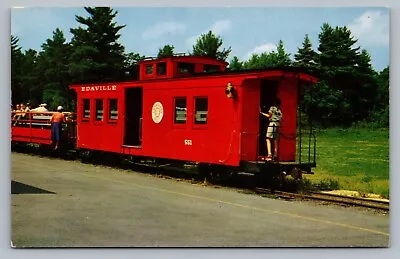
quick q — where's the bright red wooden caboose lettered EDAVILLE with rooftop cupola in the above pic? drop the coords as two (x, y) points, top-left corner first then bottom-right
(71, 56), (317, 177)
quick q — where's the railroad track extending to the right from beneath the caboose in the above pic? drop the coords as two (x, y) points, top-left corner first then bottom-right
(256, 188), (390, 211)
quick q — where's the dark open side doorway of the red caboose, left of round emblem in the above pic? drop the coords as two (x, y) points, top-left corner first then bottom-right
(124, 87), (143, 146)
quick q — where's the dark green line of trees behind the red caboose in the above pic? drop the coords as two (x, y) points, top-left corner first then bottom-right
(11, 7), (389, 127)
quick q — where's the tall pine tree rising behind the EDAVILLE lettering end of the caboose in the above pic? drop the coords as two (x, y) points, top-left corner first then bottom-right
(70, 7), (125, 81)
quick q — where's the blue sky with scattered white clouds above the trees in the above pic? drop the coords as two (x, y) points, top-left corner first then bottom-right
(11, 7), (389, 71)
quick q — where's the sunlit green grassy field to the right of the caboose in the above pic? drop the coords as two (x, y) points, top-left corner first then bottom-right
(305, 129), (389, 198)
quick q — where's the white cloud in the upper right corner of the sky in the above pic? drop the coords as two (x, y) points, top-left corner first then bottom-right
(348, 11), (389, 46)
